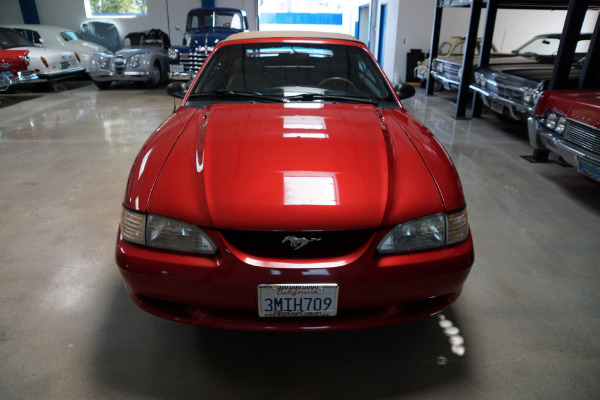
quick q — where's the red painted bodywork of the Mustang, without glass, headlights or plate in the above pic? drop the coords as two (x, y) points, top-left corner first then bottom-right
(116, 32), (474, 331)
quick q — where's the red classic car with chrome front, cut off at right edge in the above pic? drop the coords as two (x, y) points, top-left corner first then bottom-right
(528, 89), (600, 182)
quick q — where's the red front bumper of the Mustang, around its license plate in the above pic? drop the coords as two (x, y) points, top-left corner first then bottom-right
(116, 228), (474, 331)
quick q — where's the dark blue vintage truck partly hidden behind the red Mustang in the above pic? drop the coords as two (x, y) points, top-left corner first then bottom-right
(169, 7), (248, 80)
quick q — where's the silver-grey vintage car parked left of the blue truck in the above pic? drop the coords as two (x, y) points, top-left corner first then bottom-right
(89, 29), (170, 89)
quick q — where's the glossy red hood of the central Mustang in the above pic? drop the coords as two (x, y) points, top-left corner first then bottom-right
(148, 104), (443, 231)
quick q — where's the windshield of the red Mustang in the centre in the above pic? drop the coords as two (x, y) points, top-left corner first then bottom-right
(190, 42), (397, 105)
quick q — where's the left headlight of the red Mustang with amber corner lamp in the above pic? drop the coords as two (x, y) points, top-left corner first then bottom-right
(121, 206), (217, 254)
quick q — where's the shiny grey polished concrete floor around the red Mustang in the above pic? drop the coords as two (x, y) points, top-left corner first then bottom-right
(0, 81), (600, 400)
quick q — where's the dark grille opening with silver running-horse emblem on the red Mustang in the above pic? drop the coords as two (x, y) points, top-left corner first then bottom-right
(221, 230), (373, 259)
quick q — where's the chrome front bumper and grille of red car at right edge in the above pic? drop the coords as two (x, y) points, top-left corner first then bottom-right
(527, 117), (600, 182)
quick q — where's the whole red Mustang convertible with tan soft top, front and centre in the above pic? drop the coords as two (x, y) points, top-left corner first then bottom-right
(116, 32), (474, 331)
